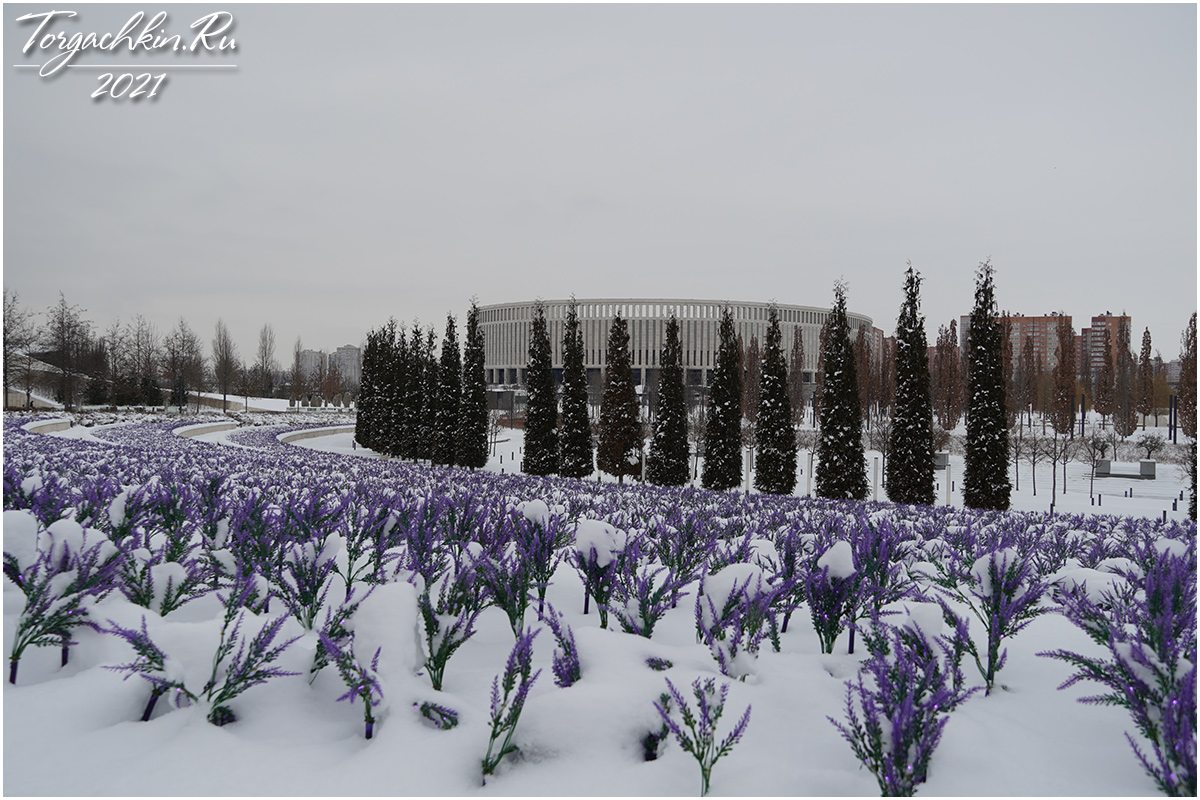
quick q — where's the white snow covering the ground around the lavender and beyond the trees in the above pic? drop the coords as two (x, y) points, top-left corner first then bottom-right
(4, 420), (1194, 796)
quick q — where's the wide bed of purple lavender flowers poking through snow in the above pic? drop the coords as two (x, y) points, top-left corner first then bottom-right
(4, 417), (1196, 792)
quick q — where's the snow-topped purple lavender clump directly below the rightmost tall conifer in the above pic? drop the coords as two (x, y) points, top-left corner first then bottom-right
(938, 548), (1050, 694)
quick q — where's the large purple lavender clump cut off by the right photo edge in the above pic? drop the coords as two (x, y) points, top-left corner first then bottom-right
(1038, 543), (1196, 796)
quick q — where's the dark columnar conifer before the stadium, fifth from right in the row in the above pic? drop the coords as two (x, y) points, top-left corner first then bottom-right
(700, 306), (742, 489)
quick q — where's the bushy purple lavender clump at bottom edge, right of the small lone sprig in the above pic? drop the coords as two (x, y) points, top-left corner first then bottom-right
(827, 615), (977, 796)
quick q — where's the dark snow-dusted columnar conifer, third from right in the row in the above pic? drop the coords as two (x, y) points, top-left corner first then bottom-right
(816, 282), (868, 500)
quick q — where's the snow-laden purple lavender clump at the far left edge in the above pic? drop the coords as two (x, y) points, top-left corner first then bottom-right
(5, 519), (120, 684)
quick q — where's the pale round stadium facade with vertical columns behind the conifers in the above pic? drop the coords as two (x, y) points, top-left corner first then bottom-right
(479, 297), (882, 389)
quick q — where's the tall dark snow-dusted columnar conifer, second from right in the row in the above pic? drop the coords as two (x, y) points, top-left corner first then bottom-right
(887, 261), (934, 505)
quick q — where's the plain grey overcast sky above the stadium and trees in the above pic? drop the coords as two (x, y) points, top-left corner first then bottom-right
(4, 4), (1196, 361)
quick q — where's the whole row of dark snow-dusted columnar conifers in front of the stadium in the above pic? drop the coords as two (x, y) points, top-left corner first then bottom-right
(355, 261), (1046, 509)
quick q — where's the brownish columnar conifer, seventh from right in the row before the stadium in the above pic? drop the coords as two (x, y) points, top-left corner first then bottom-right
(596, 314), (642, 482)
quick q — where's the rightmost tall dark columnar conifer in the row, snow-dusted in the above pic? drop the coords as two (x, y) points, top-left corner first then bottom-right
(962, 260), (1013, 511)
